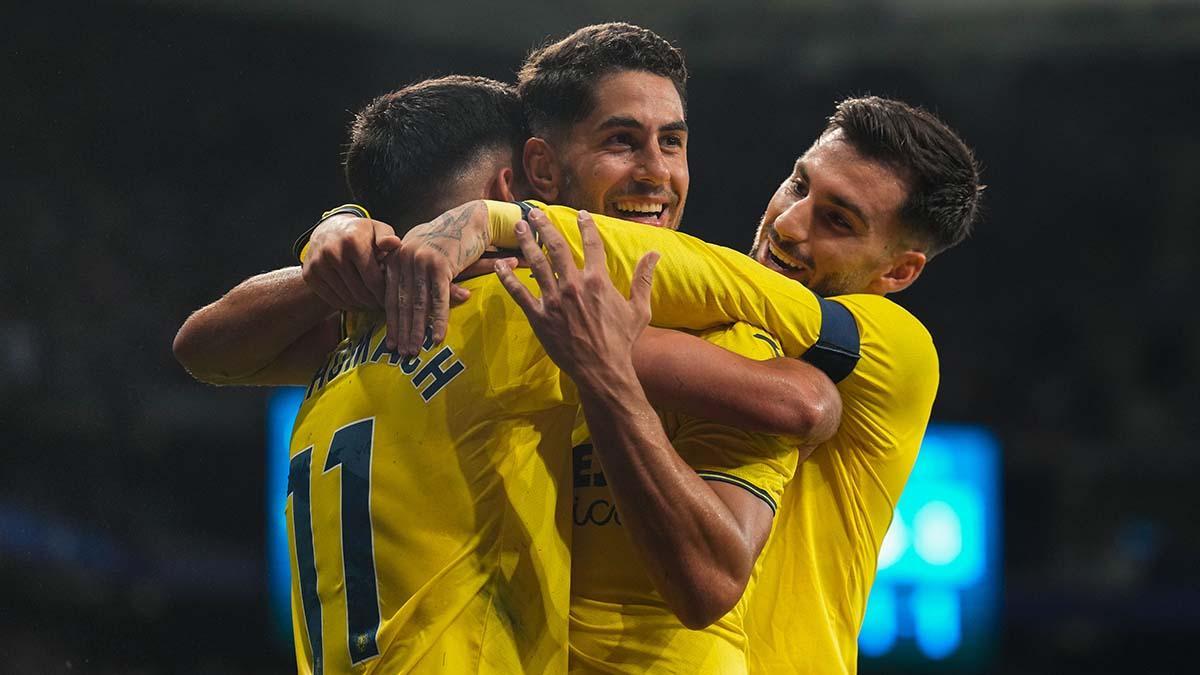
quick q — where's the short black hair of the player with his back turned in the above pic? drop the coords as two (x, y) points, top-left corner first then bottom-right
(344, 76), (529, 225)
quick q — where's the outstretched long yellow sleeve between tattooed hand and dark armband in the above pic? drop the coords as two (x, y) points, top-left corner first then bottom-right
(493, 202), (821, 357)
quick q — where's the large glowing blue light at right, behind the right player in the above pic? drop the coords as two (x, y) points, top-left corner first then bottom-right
(858, 424), (1001, 670)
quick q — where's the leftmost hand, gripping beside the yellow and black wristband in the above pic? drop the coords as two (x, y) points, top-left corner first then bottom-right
(302, 215), (396, 310)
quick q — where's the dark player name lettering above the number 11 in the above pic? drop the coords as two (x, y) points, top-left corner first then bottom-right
(304, 325), (467, 402)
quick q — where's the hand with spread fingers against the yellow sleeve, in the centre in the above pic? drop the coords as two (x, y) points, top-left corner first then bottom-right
(496, 210), (659, 387)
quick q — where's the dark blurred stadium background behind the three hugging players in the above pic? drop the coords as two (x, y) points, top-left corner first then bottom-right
(0, 0), (1200, 674)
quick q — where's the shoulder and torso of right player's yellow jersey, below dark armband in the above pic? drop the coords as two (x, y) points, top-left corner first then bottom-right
(746, 295), (938, 675)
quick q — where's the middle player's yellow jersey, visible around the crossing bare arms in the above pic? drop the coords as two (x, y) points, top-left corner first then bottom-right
(570, 323), (798, 674)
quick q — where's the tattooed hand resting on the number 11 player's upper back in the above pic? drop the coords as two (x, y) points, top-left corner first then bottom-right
(384, 201), (488, 356)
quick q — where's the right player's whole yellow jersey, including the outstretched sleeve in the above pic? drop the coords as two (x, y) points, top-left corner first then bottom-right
(492, 204), (938, 675)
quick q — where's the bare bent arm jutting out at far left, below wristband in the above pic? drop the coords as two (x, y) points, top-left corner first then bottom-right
(174, 267), (337, 384)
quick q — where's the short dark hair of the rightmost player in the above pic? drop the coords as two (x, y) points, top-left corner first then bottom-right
(824, 96), (983, 257)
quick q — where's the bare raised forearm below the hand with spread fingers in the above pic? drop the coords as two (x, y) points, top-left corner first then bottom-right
(577, 360), (757, 628)
